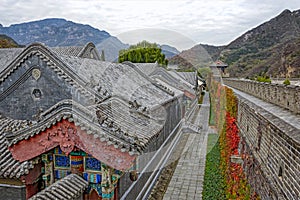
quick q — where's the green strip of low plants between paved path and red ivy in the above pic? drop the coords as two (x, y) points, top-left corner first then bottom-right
(202, 134), (226, 200)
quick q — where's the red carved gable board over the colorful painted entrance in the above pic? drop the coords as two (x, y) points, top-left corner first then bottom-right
(9, 120), (136, 171)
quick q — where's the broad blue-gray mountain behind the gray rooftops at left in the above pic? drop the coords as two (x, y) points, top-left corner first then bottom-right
(0, 18), (110, 47)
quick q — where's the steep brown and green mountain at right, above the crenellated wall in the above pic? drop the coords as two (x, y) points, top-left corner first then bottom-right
(220, 10), (300, 77)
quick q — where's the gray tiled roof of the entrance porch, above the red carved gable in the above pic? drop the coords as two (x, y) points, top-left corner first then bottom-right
(6, 97), (165, 154)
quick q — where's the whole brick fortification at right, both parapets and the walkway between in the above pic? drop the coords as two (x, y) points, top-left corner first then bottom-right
(223, 79), (300, 199)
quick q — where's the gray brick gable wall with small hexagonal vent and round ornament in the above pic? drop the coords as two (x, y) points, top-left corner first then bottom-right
(0, 56), (72, 120)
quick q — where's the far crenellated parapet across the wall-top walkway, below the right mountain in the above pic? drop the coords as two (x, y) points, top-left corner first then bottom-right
(223, 79), (300, 114)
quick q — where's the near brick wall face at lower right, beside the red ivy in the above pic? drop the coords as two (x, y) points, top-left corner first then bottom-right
(235, 96), (300, 199)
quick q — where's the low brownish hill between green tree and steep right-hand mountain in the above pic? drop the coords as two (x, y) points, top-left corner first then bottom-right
(169, 44), (224, 69)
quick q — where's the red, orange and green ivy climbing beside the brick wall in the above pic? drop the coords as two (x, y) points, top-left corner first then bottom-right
(212, 82), (257, 200)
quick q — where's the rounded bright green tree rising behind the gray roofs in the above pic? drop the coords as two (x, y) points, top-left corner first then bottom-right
(119, 41), (168, 66)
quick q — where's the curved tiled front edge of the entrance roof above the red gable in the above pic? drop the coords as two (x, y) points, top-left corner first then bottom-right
(5, 98), (154, 155)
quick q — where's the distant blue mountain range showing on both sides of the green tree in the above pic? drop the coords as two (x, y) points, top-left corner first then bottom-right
(0, 18), (179, 61)
